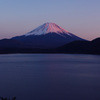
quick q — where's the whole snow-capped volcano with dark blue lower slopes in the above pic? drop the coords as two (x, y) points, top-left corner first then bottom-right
(11, 23), (85, 49)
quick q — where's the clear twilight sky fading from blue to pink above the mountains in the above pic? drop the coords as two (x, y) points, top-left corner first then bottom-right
(0, 0), (100, 40)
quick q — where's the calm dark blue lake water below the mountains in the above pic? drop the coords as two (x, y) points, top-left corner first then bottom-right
(0, 54), (100, 100)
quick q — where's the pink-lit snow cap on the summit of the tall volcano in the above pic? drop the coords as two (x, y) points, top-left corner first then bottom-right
(25, 23), (70, 36)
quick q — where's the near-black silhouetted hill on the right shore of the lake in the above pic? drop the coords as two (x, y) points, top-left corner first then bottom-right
(56, 38), (100, 54)
